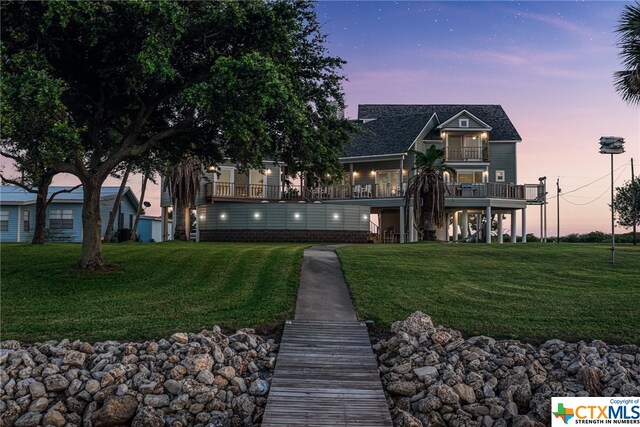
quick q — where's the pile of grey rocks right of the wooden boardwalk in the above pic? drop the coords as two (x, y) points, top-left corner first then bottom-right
(373, 312), (640, 427)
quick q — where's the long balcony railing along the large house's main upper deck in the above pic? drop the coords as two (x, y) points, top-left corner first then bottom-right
(206, 182), (544, 203)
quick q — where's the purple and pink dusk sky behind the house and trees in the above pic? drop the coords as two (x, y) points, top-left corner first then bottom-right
(26, 1), (640, 236)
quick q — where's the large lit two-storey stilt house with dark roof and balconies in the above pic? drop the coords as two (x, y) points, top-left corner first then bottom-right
(161, 104), (545, 243)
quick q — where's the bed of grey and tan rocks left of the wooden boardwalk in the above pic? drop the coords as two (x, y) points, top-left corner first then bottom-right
(0, 327), (277, 427)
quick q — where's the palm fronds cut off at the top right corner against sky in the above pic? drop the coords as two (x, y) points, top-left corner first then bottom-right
(615, 1), (640, 105)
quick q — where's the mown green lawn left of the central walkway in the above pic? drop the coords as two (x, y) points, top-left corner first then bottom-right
(0, 242), (306, 342)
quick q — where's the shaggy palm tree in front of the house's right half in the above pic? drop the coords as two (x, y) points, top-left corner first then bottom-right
(404, 145), (454, 240)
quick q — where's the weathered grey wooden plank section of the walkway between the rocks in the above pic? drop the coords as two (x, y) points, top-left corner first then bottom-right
(262, 320), (393, 427)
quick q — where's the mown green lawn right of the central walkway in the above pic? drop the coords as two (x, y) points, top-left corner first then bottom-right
(338, 243), (640, 343)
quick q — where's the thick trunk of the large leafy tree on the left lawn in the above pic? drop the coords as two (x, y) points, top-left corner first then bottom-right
(77, 180), (105, 270)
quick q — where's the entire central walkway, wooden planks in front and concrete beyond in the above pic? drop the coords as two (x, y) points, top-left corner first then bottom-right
(262, 246), (393, 427)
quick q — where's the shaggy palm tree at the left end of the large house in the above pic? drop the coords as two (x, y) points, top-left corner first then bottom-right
(166, 156), (202, 240)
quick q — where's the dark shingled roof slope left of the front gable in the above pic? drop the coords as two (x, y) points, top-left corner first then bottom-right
(344, 113), (430, 157)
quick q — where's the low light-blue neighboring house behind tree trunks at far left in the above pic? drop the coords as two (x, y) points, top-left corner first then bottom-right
(0, 186), (138, 242)
